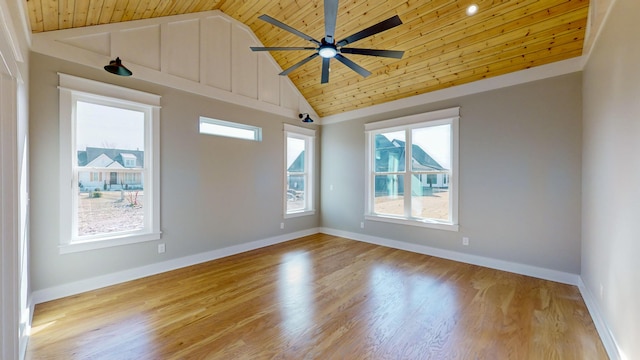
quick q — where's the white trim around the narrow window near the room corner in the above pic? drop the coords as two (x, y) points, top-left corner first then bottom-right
(282, 124), (316, 219)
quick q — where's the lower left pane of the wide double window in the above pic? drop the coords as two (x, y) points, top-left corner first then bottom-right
(374, 175), (404, 216)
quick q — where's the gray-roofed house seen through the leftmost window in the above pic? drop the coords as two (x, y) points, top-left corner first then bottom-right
(78, 147), (144, 191)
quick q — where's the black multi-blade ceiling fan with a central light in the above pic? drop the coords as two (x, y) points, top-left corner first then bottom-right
(251, 0), (404, 84)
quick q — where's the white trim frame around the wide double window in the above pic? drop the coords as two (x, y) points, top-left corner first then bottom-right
(364, 107), (460, 231)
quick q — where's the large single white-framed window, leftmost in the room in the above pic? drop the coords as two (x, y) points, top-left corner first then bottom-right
(59, 74), (160, 253)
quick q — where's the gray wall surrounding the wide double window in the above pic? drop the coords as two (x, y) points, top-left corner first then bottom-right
(321, 73), (582, 274)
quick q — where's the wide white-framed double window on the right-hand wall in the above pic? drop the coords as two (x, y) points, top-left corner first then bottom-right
(365, 108), (459, 231)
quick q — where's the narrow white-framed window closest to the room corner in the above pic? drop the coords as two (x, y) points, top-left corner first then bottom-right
(284, 124), (315, 217)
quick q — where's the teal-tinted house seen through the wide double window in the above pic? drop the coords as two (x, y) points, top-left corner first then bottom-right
(375, 134), (449, 196)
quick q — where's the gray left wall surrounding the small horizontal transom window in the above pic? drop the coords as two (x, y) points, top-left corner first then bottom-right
(29, 53), (320, 291)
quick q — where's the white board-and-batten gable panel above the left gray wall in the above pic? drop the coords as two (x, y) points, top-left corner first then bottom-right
(32, 10), (319, 119)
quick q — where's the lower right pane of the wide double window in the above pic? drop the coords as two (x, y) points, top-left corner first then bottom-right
(411, 173), (450, 221)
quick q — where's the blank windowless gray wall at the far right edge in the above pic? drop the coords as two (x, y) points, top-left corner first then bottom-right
(582, 0), (640, 359)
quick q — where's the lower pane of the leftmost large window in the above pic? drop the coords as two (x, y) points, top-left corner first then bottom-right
(77, 171), (144, 236)
